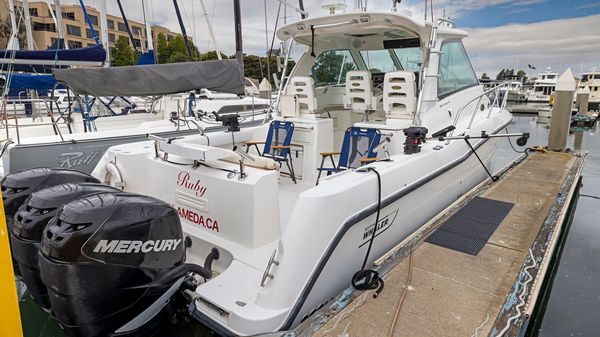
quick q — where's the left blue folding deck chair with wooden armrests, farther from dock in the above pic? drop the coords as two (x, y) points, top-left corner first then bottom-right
(245, 121), (296, 183)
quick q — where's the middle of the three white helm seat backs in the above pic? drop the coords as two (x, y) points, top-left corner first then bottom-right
(344, 70), (376, 112)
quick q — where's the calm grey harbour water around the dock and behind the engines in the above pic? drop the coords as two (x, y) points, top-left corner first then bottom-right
(16, 112), (600, 337)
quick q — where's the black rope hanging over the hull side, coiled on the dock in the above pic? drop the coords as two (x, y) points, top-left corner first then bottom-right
(352, 167), (383, 298)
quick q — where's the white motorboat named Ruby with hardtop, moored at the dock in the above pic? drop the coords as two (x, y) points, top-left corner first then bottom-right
(93, 11), (511, 336)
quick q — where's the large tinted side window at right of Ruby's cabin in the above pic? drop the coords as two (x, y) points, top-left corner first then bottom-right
(438, 41), (479, 96)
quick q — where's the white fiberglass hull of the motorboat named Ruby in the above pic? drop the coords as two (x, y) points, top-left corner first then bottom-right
(94, 111), (510, 335)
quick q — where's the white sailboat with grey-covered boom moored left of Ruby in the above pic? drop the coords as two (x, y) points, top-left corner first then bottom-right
(0, 60), (270, 175)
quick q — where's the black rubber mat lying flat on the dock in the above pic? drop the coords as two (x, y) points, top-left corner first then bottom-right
(425, 197), (514, 255)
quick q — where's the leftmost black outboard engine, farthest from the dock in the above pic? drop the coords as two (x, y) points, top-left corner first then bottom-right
(1, 168), (100, 276)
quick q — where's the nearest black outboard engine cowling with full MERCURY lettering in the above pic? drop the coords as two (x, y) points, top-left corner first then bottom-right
(39, 193), (188, 337)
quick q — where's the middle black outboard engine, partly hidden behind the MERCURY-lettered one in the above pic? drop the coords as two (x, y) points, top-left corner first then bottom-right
(11, 183), (122, 310)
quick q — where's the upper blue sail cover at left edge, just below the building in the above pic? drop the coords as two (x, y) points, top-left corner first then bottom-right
(0, 45), (106, 72)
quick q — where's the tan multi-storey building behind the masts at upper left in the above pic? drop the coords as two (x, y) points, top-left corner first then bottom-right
(0, 0), (179, 51)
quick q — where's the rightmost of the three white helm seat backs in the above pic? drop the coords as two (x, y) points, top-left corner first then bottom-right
(383, 71), (417, 120)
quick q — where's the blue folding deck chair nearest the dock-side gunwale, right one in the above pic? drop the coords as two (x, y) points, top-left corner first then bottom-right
(317, 127), (381, 185)
